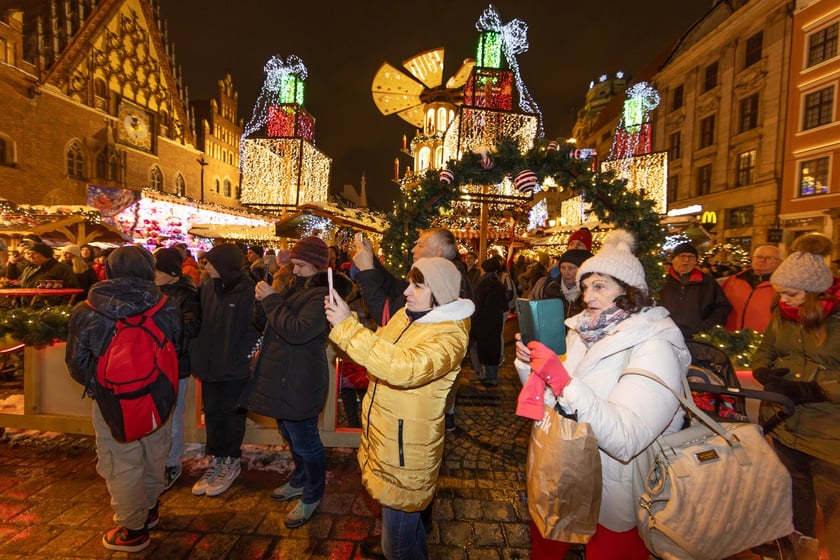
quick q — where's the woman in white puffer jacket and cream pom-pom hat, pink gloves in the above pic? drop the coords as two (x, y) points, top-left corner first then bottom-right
(515, 230), (691, 560)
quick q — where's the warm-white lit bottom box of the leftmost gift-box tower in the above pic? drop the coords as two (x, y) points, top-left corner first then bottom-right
(241, 138), (332, 207)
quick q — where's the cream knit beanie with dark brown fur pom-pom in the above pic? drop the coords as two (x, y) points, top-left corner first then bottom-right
(770, 233), (834, 294)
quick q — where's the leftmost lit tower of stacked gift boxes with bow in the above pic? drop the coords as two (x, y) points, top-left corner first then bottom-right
(240, 55), (332, 209)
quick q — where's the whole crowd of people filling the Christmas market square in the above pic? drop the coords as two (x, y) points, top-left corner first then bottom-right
(0, 224), (840, 560)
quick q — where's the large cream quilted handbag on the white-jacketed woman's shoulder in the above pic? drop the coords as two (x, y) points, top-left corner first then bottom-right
(626, 371), (793, 560)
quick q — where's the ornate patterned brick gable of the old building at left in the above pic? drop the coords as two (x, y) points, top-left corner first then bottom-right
(44, 0), (195, 144)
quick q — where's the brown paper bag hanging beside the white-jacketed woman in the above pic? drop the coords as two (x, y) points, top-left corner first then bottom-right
(526, 407), (601, 543)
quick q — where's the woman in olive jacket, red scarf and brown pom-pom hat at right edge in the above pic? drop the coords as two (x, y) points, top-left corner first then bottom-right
(752, 233), (840, 560)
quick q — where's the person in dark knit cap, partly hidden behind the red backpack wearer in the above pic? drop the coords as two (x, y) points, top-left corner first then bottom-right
(155, 247), (201, 490)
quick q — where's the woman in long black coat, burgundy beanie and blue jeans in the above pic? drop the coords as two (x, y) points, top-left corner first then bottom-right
(243, 237), (336, 528)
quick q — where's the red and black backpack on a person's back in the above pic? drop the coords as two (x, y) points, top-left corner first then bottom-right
(88, 296), (178, 442)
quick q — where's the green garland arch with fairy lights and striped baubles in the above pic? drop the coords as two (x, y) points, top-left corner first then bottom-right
(381, 138), (666, 293)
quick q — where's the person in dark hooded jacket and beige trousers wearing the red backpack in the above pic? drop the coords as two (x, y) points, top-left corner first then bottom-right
(65, 246), (180, 552)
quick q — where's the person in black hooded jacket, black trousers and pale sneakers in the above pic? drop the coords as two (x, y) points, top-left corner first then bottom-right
(190, 243), (260, 496)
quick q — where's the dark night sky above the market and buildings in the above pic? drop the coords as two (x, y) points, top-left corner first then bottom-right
(160, 0), (712, 210)
